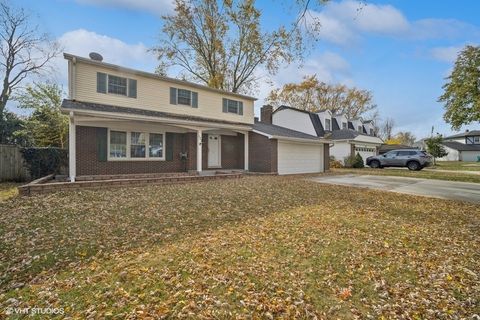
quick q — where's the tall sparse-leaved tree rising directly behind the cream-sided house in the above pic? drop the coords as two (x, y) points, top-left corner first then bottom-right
(152, 0), (323, 93)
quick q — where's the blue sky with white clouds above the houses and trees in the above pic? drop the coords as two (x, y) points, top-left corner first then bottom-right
(9, 0), (480, 138)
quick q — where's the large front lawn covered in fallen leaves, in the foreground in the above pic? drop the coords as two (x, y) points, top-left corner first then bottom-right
(0, 177), (480, 319)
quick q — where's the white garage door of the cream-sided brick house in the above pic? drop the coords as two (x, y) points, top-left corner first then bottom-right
(278, 141), (323, 174)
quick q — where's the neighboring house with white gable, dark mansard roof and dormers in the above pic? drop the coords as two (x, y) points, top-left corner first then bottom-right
(272, 106), (383, 161)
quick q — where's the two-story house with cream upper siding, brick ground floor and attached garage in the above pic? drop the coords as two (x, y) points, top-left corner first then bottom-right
(62, 54), (330, 181)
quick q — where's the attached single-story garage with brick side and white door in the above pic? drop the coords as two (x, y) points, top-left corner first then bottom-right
(248, 122), (330, 174)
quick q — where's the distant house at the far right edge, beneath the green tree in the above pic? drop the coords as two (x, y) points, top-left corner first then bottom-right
(437, 130), (480, 161)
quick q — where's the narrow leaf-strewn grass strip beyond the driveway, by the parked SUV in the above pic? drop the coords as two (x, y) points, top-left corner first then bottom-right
(331, 167), (480, 183)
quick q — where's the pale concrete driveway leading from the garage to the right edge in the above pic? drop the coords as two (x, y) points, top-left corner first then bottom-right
(310, 174), (480, 203)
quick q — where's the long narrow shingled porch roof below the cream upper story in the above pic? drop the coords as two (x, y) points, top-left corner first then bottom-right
(62, 99), (251, 130)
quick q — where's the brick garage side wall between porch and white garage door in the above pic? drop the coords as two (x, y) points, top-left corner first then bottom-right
(248, 132), (278, 172)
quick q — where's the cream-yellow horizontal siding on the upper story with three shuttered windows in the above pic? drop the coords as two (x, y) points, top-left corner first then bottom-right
(72, 61), (254, 123)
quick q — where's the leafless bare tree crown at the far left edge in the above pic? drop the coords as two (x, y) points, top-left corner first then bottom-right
(0, 1), (60, 124)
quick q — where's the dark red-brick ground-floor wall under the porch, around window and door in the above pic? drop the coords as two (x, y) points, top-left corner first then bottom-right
(76, 126), (248, 176)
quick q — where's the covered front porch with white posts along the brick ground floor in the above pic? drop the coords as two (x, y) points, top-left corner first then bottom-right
(69, 111), (250, 182)
